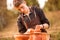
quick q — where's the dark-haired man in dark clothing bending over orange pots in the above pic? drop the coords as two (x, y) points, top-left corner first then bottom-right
(13, 0), (50, 33)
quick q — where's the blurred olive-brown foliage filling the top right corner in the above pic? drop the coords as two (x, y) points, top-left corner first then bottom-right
(45, 0), (60, 11)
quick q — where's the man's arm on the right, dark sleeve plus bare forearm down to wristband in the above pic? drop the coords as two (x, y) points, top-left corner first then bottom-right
(35, 7), (50, 28)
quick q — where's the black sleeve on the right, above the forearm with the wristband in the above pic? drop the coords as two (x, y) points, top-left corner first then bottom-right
(35, 7), (50, 26)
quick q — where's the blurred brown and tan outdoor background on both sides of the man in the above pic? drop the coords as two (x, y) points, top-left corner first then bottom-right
(0, 0), (60, 40)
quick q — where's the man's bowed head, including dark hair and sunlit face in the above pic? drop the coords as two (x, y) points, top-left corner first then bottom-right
(13, 0), (29, 13)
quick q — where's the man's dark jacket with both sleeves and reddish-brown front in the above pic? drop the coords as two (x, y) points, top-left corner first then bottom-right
(17, 7), (50, 33)
